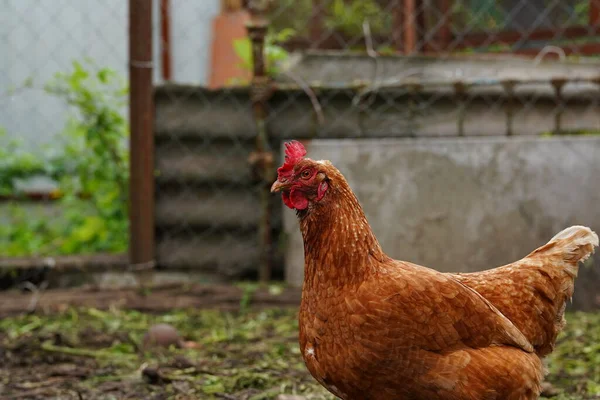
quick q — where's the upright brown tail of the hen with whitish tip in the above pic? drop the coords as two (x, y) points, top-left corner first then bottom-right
(457, 226), (598, 356)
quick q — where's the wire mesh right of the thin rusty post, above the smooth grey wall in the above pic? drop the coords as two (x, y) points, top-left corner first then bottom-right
(265, 0), (600, 284)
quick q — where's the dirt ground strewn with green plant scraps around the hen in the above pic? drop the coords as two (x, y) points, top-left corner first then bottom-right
(0, 286), (600, 400)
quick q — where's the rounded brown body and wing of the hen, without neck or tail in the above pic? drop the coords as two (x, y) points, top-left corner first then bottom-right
(300, 261), (542, 400)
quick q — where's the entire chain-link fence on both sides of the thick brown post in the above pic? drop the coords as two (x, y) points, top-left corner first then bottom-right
(0, 0), (600, 290)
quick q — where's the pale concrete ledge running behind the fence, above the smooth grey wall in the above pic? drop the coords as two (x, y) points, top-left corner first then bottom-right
(277, 51), (600, 86)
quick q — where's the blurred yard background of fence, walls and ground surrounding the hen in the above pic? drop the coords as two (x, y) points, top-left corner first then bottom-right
(0, 0), (600, 400)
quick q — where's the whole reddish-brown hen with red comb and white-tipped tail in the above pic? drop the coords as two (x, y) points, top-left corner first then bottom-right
(273, 141), (598, 400)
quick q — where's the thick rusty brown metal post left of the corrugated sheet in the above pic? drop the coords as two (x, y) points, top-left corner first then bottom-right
(129, 0), (154, 269)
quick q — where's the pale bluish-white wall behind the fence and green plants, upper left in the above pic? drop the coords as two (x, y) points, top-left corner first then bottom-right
(0, 0), (219, 151)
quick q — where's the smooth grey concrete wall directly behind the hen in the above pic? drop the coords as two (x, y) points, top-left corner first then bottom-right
(283, 137), (600, 307)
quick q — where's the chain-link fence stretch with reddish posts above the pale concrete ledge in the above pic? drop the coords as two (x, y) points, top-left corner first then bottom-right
(270, 0), (599, 56)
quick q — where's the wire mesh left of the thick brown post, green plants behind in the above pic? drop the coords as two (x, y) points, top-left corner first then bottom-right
(0, 0), (139, 289)
